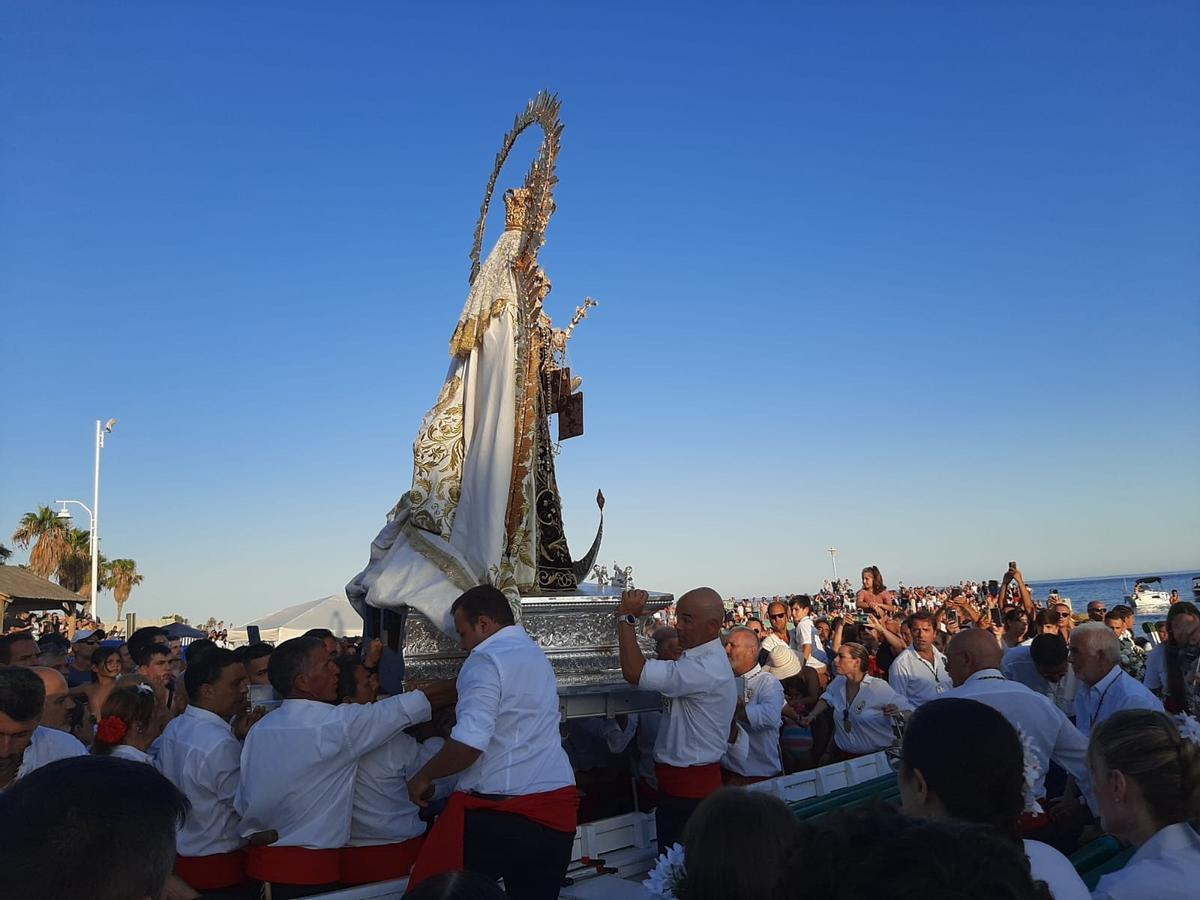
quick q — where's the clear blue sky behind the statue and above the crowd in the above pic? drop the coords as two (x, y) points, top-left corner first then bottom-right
(0, 2), (1200, 622)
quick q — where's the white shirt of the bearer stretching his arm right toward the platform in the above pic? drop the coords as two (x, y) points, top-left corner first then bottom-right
(234, 691), (430, 850)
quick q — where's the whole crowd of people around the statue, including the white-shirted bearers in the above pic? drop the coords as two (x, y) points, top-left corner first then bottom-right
(0, 564), (1200, 900)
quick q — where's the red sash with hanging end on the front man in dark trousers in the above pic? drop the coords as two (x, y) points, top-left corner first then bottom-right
(408, 785), (580, 889)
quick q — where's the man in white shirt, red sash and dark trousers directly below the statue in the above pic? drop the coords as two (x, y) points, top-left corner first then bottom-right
(408, 584), (580, 900)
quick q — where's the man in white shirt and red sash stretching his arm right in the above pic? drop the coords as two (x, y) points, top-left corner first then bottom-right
(234, 637), (454, 900)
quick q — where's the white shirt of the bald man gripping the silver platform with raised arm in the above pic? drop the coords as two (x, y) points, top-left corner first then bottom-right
(637, 638), (738, 768)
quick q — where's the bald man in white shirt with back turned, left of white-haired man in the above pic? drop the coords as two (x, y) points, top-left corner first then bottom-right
(946, 629), (1088, 836)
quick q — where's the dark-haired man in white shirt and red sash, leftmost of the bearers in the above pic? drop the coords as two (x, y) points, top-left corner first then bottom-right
(152, 648), (258, 890)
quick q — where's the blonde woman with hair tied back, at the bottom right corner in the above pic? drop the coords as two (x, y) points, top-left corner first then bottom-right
(1087, 709), (1200, 900)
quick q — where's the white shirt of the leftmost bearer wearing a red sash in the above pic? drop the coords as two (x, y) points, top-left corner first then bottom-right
(154, 704), (244, 857)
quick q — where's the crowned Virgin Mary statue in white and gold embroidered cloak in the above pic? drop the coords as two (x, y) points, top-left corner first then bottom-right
(347, 94), (602, 634)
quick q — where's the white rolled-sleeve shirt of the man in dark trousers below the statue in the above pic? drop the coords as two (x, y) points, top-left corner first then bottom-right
(450, 625), (575, 796)
